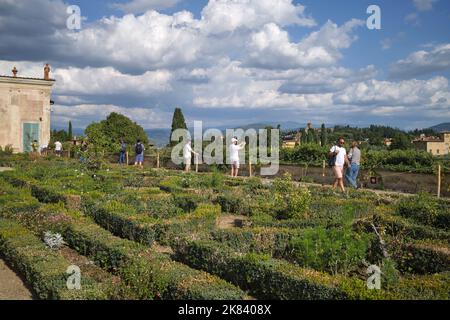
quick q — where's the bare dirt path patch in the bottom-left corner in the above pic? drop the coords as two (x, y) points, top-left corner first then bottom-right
(0, 259), (33, 300)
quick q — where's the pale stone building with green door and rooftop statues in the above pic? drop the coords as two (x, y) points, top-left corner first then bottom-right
(0, 64), (55, 152)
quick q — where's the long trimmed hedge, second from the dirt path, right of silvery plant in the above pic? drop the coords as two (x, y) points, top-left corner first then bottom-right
(2, 185), (246, 299)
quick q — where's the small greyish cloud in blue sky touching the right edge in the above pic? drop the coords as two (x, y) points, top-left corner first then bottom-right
(390, 43), (450, 78)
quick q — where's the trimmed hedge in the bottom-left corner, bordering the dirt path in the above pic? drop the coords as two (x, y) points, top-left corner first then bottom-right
(0, 218), (112, 299)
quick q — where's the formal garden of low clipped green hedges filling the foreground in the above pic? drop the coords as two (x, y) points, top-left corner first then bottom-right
(0, 159), (450, 299)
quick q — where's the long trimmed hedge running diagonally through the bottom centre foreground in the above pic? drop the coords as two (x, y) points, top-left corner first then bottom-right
(174, 240), (380, 300)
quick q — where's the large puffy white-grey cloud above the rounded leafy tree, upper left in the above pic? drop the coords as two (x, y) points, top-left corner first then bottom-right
(58, 11), (203, 70)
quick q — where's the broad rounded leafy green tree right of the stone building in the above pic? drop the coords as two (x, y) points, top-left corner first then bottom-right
(85, 112), (148, 152)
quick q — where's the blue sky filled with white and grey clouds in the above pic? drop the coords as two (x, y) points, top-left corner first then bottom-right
(0, 0), (450, 129)
